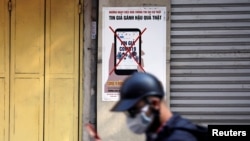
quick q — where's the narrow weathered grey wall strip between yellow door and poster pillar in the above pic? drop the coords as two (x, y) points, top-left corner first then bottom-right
(80, 0), (98, 141)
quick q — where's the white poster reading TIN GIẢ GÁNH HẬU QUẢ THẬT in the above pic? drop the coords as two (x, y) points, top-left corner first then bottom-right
(102, 7), (166, 101)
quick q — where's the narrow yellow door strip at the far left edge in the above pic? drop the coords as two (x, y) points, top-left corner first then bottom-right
(0, 0), (9, 141)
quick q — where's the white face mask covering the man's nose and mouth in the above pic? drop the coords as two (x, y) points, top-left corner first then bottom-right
(127, 105), (154, 134)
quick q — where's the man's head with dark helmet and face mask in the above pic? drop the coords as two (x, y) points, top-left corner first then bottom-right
(111, 73), (164, 134)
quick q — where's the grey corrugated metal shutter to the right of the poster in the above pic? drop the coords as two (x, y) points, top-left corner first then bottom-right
(170, 0), (250, 125)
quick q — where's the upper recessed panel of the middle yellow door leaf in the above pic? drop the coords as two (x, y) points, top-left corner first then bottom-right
(12, 0), (44, 74)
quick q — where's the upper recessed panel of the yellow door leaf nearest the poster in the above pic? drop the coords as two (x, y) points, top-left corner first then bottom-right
(48, 0), (79, 74)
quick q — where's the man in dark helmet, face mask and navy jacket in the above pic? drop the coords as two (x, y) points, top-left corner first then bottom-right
(111, 72), (207, 141)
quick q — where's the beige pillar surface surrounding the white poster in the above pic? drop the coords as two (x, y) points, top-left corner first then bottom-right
(97, 0), (170, 141)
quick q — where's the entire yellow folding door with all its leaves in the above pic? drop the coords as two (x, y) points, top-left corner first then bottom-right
(0, 0), (81, 141)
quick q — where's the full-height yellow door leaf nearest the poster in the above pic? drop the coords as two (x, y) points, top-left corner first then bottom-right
(44, 0), (80, 141)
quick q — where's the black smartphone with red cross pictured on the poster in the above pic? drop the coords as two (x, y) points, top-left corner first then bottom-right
(114, 28), (141, 75)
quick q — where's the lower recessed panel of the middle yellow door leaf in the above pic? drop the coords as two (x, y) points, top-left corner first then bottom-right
(11, 78), (43, 141)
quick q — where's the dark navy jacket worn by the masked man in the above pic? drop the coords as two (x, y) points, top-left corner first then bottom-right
(146, 113), (207, 141)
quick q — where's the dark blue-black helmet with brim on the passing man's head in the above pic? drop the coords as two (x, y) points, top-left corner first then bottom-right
(111, 72), (164, 111)
